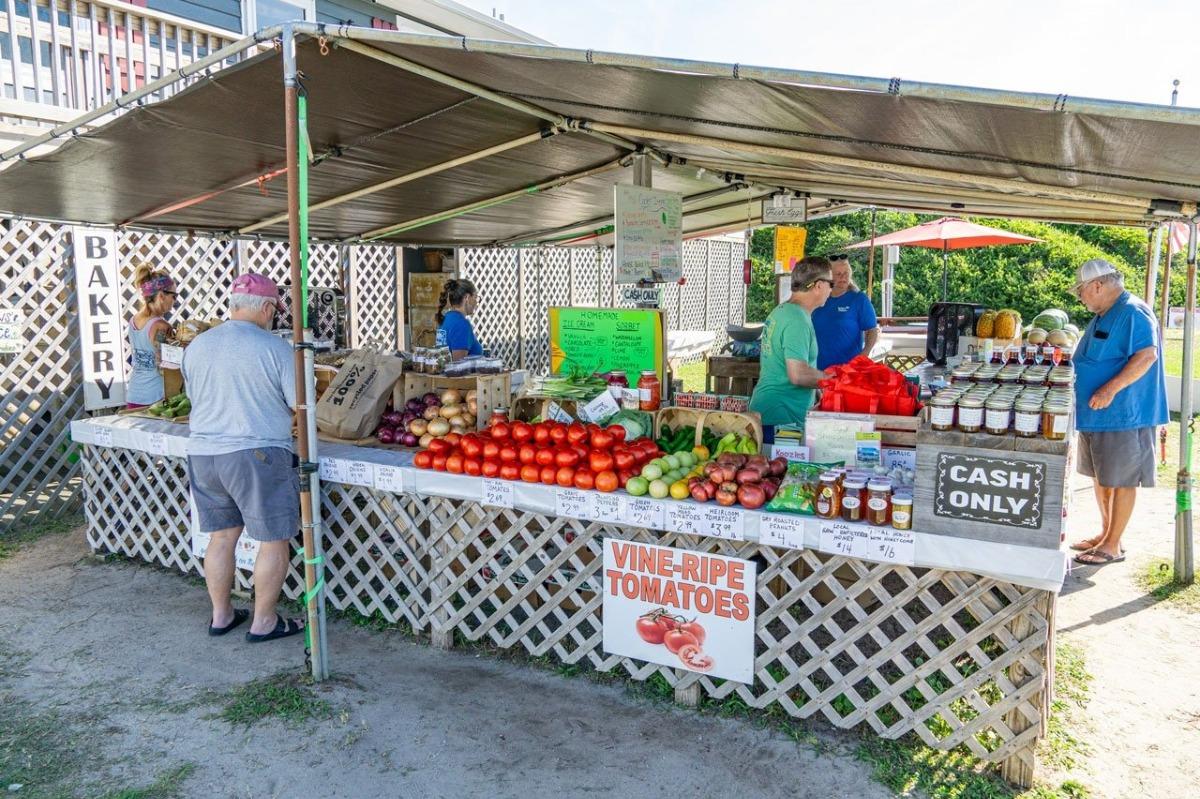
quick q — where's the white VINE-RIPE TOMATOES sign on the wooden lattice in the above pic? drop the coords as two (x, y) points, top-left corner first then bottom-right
(604, 539), (757, 683)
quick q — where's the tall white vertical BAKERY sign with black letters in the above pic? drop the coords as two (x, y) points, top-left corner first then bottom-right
(71, 227), (125, 410)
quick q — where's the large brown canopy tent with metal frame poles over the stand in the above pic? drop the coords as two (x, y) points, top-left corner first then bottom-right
(0, 23), (1200, 675)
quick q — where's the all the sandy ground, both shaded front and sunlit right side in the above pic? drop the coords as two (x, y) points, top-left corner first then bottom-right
(0, 475), (1200, 799)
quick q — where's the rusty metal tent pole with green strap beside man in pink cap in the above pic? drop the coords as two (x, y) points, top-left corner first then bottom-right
(282, 25), (329, 680)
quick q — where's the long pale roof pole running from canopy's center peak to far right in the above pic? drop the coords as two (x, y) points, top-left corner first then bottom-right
(581, 122), (1150, 212)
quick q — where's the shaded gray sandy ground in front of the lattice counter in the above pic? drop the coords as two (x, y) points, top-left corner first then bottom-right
(0, 533), (890, 799)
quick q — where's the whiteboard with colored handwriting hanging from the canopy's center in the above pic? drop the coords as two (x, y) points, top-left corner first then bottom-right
(613, 186), (683, 283)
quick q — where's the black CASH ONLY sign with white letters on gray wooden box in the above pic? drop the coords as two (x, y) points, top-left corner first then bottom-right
(934, 452), (1046, 529)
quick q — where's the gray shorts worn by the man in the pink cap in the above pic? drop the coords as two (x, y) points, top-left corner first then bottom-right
(187, 446), (300, 541)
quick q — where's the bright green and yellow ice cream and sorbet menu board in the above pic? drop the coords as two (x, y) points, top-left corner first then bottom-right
(550, 307), (666, 386)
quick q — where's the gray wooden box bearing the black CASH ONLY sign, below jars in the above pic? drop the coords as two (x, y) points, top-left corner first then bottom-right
(913, 428), (1074, 549)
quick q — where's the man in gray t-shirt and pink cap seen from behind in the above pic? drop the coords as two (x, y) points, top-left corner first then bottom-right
(182, 274), (304, 643)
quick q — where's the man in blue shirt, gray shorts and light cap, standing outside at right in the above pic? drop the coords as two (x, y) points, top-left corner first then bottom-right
(1072, 258), (1169, 566)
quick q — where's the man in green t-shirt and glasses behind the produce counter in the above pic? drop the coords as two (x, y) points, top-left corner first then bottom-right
(750, 258), (833, 425)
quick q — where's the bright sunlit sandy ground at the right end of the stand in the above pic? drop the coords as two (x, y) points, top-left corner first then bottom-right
(1057, 481), (1200, 799)
